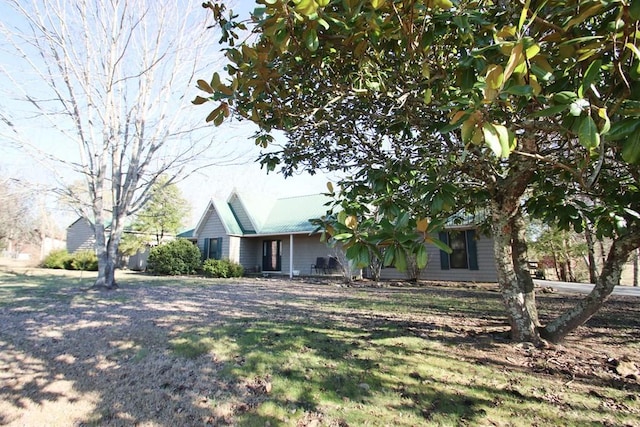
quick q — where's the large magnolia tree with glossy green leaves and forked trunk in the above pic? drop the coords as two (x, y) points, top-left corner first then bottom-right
(194, 0), (640, 342)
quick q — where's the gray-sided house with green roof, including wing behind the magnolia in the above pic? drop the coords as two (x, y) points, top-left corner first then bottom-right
(190, 191), (497, 282)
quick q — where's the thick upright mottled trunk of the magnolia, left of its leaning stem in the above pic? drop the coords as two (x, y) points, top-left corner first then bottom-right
(491, 202), (540, 344)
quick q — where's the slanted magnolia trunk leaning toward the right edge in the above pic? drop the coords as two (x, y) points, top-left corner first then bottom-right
(540, 229), (640, 343)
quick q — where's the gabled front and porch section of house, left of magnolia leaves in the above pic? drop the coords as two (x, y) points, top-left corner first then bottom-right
(193, 192), (331, 277)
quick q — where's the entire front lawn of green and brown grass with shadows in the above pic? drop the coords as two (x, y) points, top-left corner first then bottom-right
(0, 270), (640, 426)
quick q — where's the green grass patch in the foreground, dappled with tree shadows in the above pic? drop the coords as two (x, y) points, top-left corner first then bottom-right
(172, 307), (631, 426)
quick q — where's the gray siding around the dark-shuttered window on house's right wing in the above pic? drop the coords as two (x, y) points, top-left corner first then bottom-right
(381, 232), (498, 282)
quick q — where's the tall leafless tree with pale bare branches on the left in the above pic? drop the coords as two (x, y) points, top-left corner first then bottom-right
(0, 0), (235, 288)
